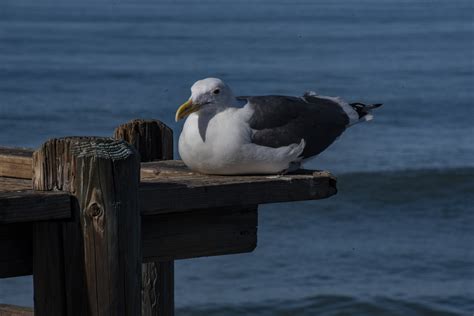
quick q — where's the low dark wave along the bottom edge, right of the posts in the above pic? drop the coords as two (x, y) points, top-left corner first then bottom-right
(177, 295), (465, 316)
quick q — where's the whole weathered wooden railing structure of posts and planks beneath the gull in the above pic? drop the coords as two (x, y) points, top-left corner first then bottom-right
(0, 120), (336, 316)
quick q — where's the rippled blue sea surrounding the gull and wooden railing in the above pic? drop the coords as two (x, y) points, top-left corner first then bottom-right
(0, 0), (474, 316)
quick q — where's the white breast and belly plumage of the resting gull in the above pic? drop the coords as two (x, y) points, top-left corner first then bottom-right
(178, 107), (304, 174)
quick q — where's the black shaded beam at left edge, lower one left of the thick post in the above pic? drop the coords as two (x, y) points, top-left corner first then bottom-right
(0, 223), (32, 278)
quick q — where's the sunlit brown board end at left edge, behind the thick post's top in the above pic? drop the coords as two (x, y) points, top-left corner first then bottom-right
(0, 147), (33, 179)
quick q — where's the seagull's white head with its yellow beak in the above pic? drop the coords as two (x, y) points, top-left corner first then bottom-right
(175, 78), (234, 122)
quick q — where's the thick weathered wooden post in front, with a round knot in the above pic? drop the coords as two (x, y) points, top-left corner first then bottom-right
(33, 137), (142, 316)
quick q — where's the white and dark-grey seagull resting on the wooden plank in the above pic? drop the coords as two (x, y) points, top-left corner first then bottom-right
(175, 78), (381, 175)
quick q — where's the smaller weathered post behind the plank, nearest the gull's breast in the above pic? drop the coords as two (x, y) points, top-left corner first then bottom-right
(114, 120), (174, 316)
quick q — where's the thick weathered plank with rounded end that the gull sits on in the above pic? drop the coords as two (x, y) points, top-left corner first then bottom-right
(140, 160), (337, 215)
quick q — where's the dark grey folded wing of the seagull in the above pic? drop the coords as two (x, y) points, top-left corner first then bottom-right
(238, 94), (349, 158)
